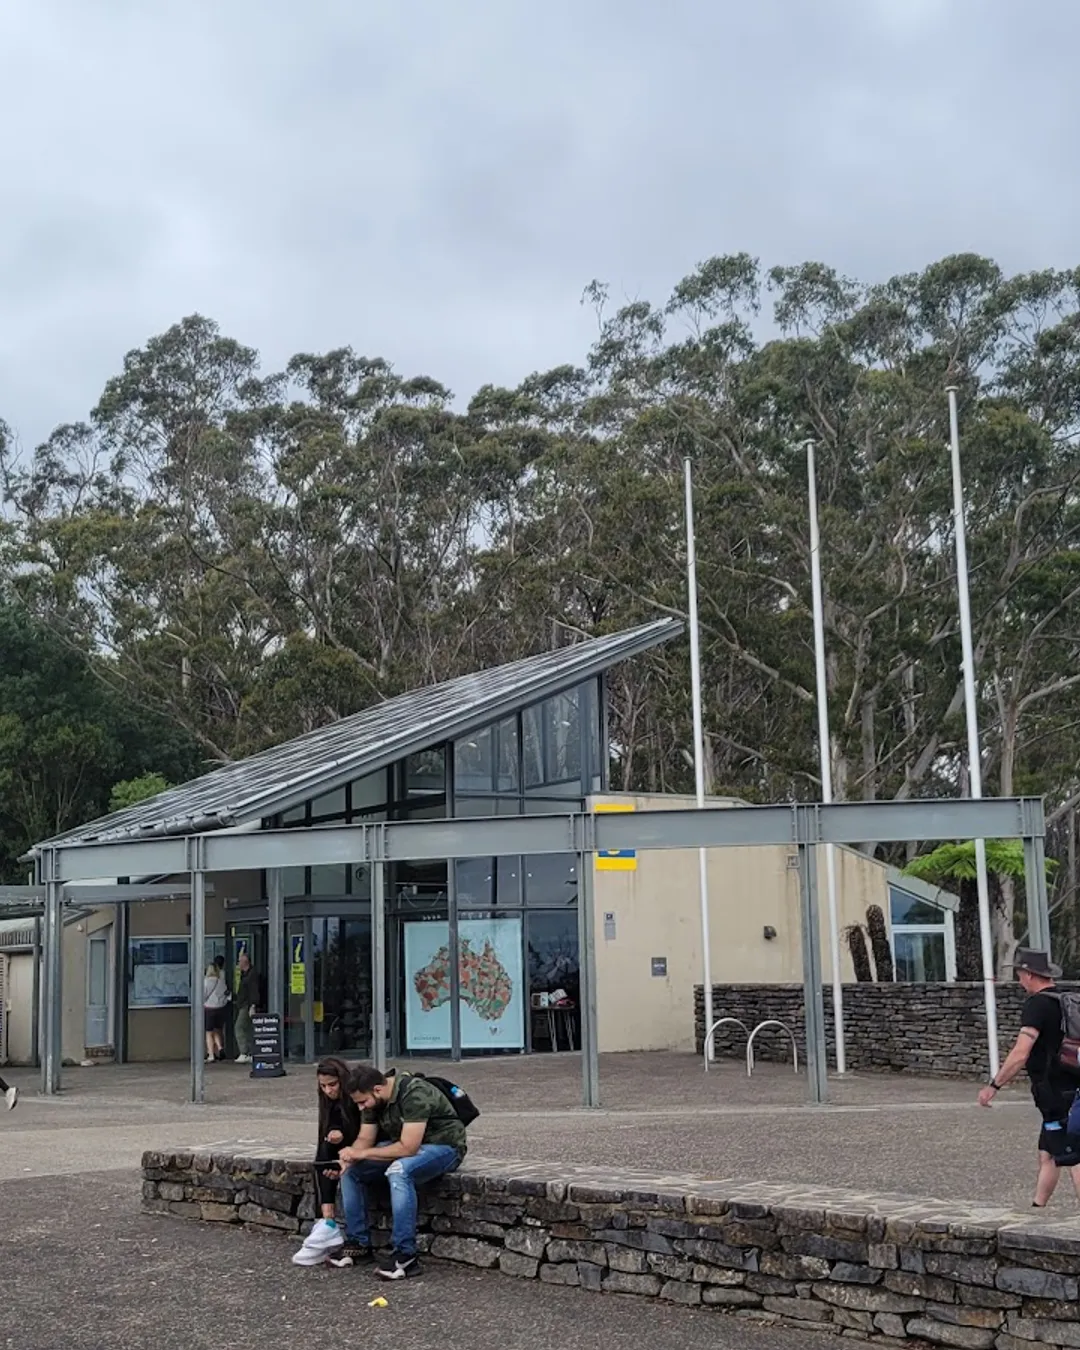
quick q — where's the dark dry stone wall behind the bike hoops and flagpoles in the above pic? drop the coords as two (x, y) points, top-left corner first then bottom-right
(694, 984), (1080, 1079)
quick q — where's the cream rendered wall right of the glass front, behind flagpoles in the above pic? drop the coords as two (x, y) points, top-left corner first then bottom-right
(593, 794), (888, 1050)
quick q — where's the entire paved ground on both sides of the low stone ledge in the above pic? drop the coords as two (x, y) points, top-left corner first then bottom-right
(0, 1054), (1077, 1350)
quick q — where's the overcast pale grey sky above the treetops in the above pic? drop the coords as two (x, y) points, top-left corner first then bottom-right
(0, 0), (1080, 448)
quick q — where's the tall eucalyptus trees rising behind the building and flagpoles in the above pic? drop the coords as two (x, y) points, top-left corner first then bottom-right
(0, 254), (1080, 954)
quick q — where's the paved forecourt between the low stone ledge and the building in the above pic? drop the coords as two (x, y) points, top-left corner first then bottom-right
(0, 1054), (1076, 1212)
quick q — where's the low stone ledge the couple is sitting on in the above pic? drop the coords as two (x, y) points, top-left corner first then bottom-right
(142, 1141), (1080, 1350)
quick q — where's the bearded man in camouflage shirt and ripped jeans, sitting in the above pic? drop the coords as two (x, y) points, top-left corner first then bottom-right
(331, 1064), (466, 1280)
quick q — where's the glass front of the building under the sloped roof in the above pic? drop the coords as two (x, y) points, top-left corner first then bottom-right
(228, 680), (608, 1060)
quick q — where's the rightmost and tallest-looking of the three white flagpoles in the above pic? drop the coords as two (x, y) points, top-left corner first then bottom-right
(945, 385), (1002, 1079)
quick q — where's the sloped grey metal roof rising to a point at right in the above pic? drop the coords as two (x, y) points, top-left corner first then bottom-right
(34, 618), (683, 853)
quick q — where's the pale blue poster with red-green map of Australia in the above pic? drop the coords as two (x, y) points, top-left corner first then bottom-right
(405, 918), (527, 1050)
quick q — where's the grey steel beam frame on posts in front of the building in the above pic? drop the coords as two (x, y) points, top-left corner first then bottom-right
(31, 798), (1049, 1106)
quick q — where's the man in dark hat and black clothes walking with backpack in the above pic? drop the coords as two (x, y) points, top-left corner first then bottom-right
(979, 946), (1080, 1210)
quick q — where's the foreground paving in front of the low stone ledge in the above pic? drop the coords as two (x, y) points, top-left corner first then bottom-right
(0, 1170), (836, 1350)
